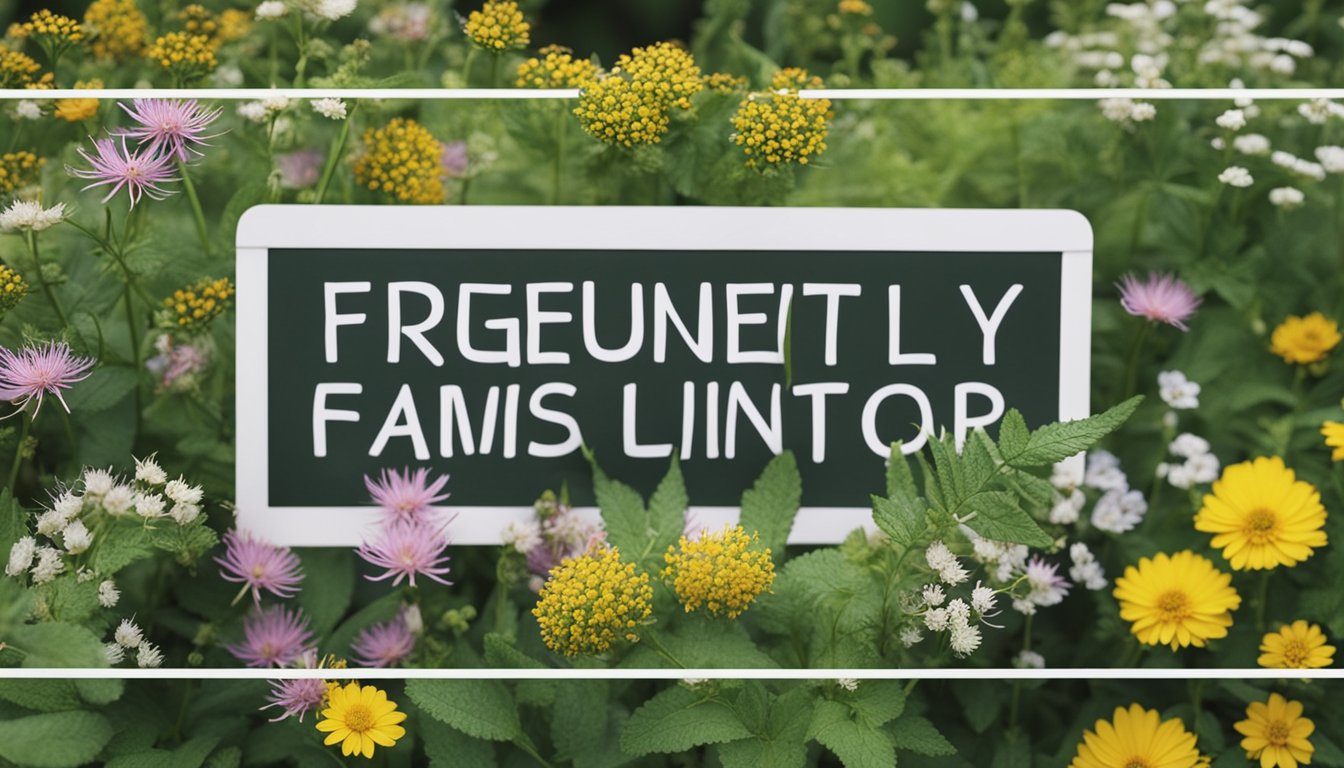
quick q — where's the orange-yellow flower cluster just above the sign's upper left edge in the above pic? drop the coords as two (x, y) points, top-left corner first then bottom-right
(355, 117), (446, 204)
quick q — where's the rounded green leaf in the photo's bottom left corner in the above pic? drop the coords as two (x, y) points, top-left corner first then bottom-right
(0, 712), (113, 768)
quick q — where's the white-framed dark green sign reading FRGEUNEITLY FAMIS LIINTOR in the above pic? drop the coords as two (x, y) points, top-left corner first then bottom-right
(237, 206), (1093, 546)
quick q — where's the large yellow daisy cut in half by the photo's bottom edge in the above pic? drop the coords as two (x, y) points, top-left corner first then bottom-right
(1068, 703), (1204, 768)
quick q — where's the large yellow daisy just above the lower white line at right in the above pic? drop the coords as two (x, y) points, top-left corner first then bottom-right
(1114, 550), (1242, 651)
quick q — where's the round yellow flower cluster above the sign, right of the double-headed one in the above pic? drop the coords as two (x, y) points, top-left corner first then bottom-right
(732, 67), (831, 168)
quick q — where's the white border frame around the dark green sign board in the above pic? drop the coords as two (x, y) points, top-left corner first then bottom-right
(235, 204), (1093, 547)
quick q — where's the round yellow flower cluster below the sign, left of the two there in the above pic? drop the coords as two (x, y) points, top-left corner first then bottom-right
(532, 547), (653, 656)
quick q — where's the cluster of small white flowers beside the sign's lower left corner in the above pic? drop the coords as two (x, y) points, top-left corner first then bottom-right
(5, 457), (203, 589)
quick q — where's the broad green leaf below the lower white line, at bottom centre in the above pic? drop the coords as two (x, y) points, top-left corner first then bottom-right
(621, 686), (751, 757)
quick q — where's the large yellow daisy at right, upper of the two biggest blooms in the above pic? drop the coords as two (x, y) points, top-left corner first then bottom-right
(1195, 456), (1325, 570)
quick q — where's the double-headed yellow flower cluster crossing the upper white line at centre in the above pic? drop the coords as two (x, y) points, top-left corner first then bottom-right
(574, 43), (704, 147)
